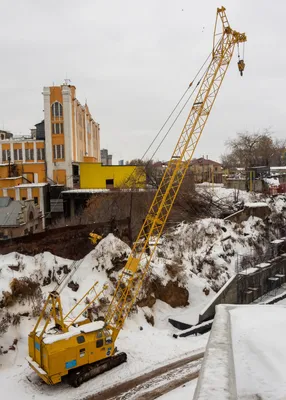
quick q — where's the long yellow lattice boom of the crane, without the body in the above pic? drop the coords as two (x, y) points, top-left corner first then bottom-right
(105, 7), (246, 337)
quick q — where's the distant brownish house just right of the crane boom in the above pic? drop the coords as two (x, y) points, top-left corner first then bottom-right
(190, 157), (223, 183)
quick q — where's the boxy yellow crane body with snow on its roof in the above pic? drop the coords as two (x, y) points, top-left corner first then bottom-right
(27, 321), (126, 386)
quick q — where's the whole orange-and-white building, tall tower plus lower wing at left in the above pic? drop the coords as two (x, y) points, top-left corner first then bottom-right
(0, 84), (100, 228)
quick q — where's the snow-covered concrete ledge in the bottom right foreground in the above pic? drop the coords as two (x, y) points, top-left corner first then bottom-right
(194, 305), (286, 400)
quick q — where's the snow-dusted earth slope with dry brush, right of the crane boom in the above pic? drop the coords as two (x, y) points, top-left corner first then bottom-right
(153, 217), (267, 290)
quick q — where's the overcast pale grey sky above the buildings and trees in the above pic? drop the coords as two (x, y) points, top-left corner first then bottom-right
(0, 0), (286, 162)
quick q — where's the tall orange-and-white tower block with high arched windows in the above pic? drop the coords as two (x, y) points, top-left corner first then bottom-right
(43, 84), (100, 188)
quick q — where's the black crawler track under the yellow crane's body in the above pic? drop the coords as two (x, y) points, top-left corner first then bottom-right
(67, 353), (127, 387)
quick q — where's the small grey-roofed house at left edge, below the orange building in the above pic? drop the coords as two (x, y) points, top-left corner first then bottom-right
(0, 197), (43, 240)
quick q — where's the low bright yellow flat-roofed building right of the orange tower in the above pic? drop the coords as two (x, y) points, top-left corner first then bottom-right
(80, 162), (146, 189)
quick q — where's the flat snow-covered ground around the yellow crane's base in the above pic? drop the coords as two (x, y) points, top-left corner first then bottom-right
(0, 311), (208, 400)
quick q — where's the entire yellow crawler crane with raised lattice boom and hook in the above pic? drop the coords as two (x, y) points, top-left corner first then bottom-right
(28, 7), (246, 386)
